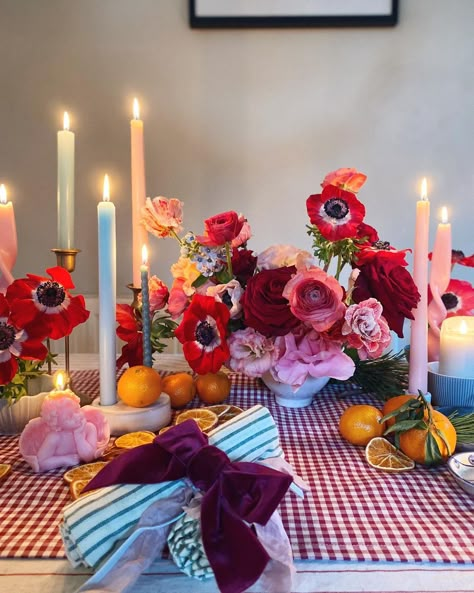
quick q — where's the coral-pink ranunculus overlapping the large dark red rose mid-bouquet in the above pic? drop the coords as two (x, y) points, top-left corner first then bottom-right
(283, 267), (346, 332)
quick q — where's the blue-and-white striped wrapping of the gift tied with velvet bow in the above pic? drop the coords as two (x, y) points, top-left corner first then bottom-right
(60, 405), (283, 570)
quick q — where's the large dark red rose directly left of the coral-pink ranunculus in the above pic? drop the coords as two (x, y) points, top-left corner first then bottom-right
(241, 266), (301, 337)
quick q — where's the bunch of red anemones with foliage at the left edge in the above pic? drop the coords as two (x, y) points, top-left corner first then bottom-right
(0, 267), (89, 430)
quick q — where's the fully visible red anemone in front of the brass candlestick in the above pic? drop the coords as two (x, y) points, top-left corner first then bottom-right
(6, 266), (89, 340)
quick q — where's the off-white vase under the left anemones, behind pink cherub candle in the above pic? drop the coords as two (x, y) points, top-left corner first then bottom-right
(0, 375), (53, 434)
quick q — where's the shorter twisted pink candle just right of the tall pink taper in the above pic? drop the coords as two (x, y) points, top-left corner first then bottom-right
(428, 206), (452, 337)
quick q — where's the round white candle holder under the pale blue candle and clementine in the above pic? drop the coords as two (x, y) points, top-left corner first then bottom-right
(92, 393), (171, 436)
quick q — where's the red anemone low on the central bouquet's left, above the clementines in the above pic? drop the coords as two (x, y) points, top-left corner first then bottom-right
(175, 294), (230, 375)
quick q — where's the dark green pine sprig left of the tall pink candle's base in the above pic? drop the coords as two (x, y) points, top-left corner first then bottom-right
(346, 350), (408, 400)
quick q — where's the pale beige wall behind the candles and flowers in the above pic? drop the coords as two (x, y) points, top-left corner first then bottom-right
(0, 0), (474, 295)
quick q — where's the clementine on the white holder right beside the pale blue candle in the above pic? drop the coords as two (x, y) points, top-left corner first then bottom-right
(117, 365), (161, 408)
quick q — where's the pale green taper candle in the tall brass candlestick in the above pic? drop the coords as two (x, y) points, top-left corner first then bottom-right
(58, 112), (74, 249)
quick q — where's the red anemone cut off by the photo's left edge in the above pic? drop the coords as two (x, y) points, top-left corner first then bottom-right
(0, 294), (48, 385)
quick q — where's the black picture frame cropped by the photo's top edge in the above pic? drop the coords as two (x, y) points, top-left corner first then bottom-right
(189, 0), (398, 29)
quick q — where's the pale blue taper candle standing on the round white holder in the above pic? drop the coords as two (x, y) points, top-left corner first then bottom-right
(97, 175), (117, 406)
